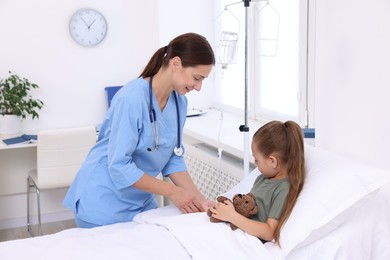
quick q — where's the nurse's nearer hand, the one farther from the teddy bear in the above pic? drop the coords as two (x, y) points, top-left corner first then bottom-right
(169, 186), (204, 213)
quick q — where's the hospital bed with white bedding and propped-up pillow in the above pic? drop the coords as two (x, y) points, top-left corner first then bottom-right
(0, 146), (390, 260)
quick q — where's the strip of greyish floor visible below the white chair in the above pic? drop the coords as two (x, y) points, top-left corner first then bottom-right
(0, 219), (76, 242)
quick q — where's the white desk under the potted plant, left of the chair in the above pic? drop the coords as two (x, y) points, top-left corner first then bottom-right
(0, 134), (37, 196)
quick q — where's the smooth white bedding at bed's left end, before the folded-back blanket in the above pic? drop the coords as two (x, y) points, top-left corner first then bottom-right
(0, 222), (190, 260)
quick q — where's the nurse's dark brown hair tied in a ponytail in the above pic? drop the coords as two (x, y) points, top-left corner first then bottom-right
(140, 33), (215, 77)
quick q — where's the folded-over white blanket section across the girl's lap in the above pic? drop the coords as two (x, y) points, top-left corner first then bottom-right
(134, 207), (273, 260)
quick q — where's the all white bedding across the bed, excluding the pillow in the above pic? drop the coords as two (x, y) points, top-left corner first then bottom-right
(0, 184), (390, 260)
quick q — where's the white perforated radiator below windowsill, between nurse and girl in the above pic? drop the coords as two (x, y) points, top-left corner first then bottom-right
(184, 143), (254, 200)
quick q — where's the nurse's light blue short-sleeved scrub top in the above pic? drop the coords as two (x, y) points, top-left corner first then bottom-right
(64, 78), (187, 225)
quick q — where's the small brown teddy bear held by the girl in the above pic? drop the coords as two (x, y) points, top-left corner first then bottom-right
(207, 193), (257, 230)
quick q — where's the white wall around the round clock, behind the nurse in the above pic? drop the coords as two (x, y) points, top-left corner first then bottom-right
(0, 0), (159, 131)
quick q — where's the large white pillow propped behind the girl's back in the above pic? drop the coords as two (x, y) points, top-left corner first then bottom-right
(224, 146), (390, 256)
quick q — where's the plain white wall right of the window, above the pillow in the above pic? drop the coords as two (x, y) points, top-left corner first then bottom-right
(315, 0), (390, 172)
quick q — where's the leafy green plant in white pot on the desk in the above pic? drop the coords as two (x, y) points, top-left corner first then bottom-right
(0, 71), (43, 134)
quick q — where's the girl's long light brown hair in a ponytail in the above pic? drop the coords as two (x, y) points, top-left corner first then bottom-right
(253, 121), (306, 245)
